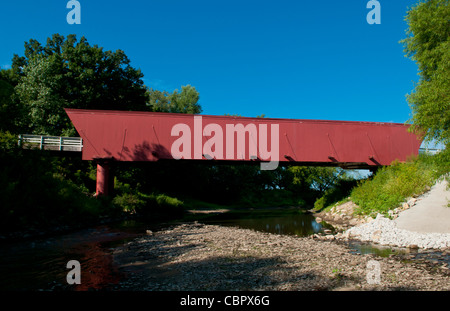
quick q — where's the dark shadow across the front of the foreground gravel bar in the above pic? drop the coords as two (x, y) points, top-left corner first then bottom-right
(114, 251), (331, 291)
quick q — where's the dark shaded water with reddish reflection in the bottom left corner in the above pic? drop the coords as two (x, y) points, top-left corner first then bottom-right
(0, 226), (137, 291)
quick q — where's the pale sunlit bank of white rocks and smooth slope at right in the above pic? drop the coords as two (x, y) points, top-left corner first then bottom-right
(315, 179), (450, 250)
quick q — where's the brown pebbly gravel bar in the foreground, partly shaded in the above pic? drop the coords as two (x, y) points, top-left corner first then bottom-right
(113, 223), (450, 291)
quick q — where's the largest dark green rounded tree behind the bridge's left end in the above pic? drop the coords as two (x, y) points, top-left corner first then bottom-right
(12, 34), (148, 135)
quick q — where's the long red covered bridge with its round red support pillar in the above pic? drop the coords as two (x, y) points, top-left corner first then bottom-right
(66, 109), (421, 195)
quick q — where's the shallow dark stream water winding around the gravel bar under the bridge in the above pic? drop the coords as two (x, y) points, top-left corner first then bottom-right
(0, 209), (450, 290)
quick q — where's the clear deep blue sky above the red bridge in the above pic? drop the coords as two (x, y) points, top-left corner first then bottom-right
(0, 0), (418, 123)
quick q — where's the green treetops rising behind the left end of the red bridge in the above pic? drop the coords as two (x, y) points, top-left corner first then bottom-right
(5, 34), (202, 136)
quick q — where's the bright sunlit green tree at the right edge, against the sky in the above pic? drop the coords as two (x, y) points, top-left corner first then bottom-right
(401, 0), (450, 146)
